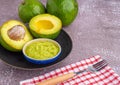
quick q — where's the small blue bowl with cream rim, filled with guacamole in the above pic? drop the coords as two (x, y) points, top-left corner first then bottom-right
(23, 38), (61, 64)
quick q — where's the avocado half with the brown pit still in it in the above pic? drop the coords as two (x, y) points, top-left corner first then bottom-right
(0, 20), (33, 52)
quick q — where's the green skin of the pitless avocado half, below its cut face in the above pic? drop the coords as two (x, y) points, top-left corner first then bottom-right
(30, 30), (61, 39)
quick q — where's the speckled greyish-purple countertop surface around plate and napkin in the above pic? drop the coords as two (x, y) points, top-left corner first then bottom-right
(0, 0), (120, 85)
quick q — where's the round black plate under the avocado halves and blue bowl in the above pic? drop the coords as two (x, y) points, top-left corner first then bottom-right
(0, 30), (72, 69)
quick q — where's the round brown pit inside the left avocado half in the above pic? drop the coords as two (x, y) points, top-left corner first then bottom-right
(7, 25), (25, 41)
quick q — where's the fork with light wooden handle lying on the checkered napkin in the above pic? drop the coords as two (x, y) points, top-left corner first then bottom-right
(36, 59), (108, 85)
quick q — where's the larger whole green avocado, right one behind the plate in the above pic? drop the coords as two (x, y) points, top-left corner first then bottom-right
(46, 0), (78, 26)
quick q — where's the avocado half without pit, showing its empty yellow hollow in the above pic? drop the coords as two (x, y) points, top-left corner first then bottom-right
(29, 14), (62, 39)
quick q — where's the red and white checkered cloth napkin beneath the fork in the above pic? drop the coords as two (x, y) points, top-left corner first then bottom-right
(20, 55), (120, 85)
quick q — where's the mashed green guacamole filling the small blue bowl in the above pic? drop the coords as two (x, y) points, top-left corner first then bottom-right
(25, 41), (60, 60)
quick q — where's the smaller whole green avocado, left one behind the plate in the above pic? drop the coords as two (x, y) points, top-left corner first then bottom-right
(18, 0), (45, 23)
